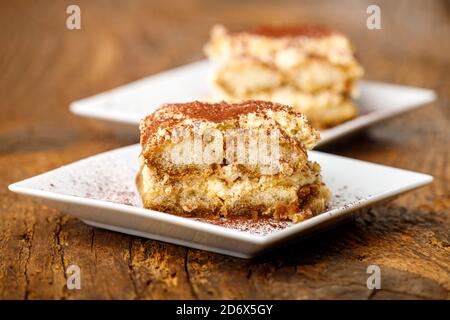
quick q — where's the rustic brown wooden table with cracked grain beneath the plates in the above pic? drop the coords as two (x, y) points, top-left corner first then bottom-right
(0, 0), (450, 299)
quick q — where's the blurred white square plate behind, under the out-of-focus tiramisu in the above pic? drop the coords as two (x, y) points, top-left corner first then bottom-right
(70, 60), (436, 145)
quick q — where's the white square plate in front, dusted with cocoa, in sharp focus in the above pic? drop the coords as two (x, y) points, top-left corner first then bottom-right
(9, 145), (433, 258)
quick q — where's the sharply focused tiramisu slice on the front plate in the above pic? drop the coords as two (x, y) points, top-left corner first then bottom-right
(136, 101), (330, 222)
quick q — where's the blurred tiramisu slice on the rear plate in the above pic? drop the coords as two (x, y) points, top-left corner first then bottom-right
(205, 26), (363, 129)
